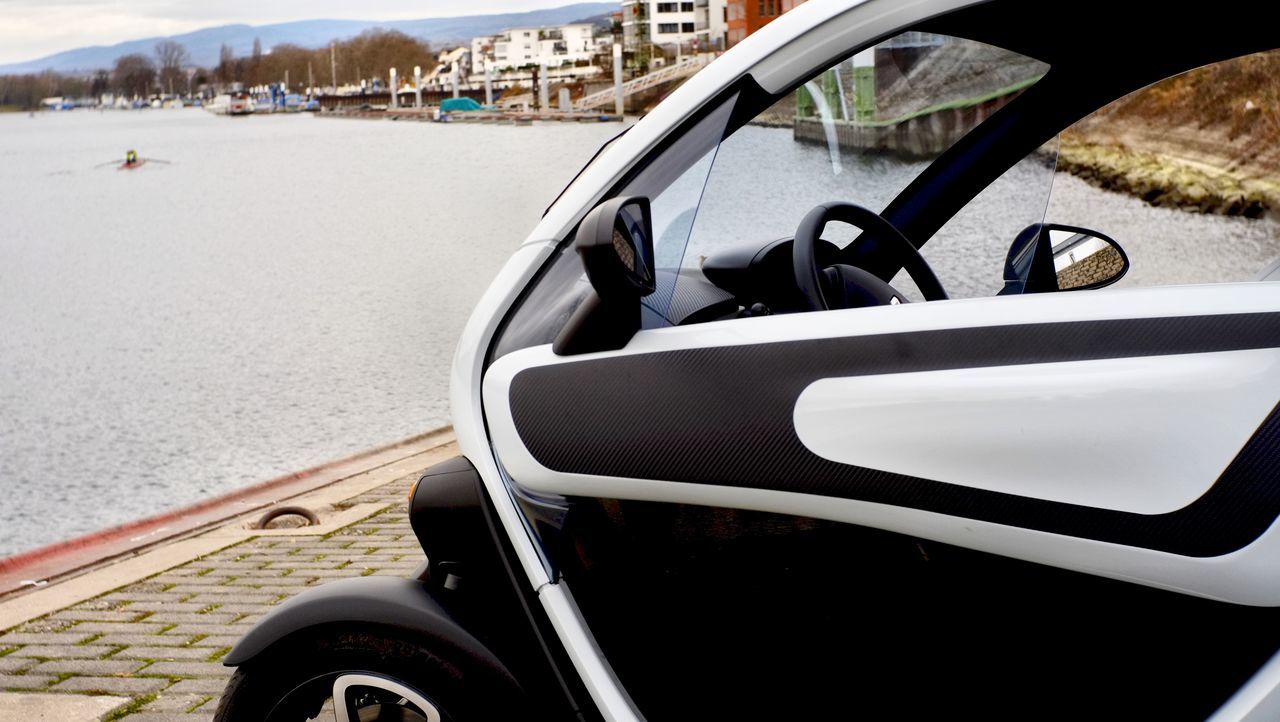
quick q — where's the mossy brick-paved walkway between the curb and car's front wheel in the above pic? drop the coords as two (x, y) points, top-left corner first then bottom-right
(0, 443), (457, 722)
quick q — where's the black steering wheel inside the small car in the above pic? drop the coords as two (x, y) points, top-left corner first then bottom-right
(791, 201), (947, 311)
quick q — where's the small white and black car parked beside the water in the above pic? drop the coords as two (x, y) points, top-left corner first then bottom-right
(218, 0), (1280, 722)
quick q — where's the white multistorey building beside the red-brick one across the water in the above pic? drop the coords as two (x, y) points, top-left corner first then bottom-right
(622, 0), (728, 51)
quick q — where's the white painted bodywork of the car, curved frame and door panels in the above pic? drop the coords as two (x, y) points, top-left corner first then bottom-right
(451, 0), (1280, 722)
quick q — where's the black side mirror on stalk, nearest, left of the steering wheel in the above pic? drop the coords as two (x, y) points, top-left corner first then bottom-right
(552, 196), (655, 356)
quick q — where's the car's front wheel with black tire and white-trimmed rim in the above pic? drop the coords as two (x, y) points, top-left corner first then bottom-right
(214, 631), (527, 722)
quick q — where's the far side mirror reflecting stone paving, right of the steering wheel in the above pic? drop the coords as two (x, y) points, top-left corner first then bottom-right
(1000, 223), (1129, 296)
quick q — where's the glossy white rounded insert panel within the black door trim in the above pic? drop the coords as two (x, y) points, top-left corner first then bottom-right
(792, 348), (1280, 515)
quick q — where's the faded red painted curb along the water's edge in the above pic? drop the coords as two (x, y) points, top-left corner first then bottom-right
(0, 426), (449, 597)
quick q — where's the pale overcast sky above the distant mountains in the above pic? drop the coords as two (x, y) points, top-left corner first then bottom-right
(0, 0), (580, 64)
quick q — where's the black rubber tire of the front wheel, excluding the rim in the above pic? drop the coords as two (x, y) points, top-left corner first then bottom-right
(214, 629), (522, 722)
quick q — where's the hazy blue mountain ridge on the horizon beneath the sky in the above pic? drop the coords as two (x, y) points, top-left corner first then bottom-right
(0, 3), (620, 74)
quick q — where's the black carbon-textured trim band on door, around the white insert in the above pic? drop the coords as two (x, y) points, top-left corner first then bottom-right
(511, 312), (1280, 557)
